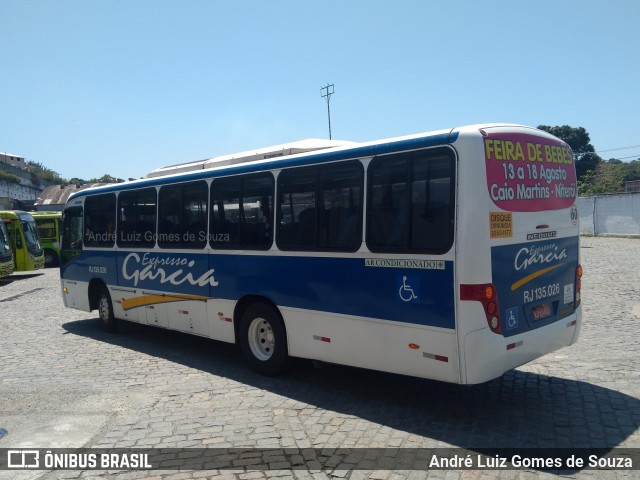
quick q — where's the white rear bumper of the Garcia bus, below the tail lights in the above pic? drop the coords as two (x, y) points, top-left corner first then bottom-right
(462, 307), (582, 385)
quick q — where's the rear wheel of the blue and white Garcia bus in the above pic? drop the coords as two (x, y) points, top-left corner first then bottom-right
(240, 303), (289, 376)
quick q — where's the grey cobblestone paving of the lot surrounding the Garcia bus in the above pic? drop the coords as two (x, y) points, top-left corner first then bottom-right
(0, 237), (640, 480)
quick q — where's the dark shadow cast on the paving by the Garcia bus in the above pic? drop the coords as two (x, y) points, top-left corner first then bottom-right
(63, 320), (640, 470)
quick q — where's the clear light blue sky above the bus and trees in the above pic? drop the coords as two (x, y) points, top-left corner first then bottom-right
(0, 0), (640, 179)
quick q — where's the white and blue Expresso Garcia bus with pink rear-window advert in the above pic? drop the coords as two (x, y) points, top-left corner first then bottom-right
(61, 124), (582, 384)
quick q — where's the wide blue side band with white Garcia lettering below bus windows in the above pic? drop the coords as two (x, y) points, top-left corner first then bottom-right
(64, 250), (455, 329)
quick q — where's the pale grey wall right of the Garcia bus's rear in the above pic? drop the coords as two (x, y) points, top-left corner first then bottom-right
(576, 193), (640, 236)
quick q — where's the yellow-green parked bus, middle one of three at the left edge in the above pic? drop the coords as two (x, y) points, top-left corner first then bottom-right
(0, 210), (44, 272)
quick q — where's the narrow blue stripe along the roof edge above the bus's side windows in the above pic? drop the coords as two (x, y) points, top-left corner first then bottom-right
(68, 132), (459, 202)
